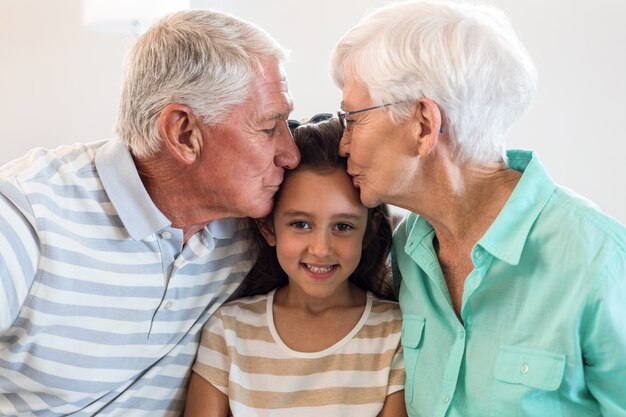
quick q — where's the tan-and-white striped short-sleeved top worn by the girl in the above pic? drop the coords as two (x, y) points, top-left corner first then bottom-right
(193, 290), (404, 417)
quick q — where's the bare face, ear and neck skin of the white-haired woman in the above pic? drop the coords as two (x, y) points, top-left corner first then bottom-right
(340, 75), (521, 316)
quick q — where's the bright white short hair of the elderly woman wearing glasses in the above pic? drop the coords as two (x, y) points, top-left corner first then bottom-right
(331, 0), (537, 164)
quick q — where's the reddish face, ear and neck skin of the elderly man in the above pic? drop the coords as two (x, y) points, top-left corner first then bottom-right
(136, 61), (299, 241)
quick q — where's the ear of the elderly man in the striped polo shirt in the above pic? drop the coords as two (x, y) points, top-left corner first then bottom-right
(158, 103), (203, 165)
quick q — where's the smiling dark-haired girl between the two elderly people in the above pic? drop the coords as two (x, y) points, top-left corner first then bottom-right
(185, 119), (406, 417)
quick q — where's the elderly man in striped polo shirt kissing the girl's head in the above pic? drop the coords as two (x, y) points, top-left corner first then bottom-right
(0, 11), (299, 416)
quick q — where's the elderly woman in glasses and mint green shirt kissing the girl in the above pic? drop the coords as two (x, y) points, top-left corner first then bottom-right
(332, 1), (626, 416)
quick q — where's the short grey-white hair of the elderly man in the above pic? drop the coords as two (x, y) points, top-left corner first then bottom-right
(115, 10), (287, 158)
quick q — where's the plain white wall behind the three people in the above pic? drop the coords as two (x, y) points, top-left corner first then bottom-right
(0, 0), (626, 223)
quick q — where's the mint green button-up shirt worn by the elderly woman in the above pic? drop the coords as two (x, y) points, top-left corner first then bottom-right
(392, 151), (626, 417)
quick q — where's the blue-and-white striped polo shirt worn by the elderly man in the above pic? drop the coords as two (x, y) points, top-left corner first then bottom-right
(0, 140), (254, 417)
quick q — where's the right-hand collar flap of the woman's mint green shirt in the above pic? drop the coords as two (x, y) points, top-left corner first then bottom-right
(477, 150), (556, 265)
